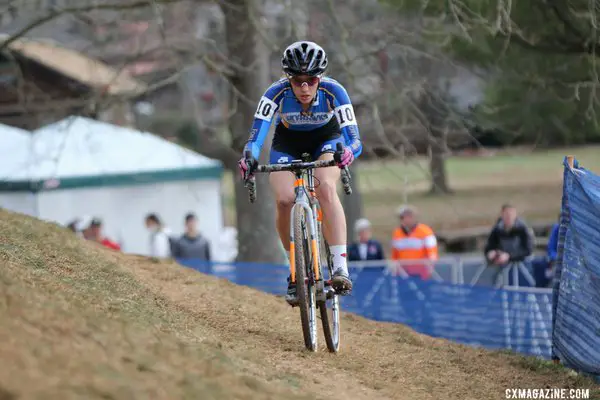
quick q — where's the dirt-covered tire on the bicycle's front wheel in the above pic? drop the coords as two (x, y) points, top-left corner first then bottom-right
(293, 207), (317, 351)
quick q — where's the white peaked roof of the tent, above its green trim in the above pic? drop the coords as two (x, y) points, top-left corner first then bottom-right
(0, 116), (221, 181)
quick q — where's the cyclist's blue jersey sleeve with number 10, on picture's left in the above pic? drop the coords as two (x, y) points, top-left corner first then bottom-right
(244, 80), (287, 159)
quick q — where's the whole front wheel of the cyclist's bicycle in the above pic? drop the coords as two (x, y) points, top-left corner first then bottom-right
(293, 207), (317, 351)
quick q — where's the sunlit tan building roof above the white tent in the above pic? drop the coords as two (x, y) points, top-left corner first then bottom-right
(0, 34), (146, 95)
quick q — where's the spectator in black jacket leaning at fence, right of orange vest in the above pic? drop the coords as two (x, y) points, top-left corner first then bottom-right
(485, 204), (533, 284)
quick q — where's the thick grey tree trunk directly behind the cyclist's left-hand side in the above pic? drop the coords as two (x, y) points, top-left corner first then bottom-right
(222, 0), (285, 263)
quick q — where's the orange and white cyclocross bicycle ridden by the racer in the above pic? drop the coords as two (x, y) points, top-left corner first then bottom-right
(245, 143), (352, 352)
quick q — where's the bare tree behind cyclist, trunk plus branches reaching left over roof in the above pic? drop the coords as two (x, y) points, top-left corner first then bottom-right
(0, 0), (284, 263)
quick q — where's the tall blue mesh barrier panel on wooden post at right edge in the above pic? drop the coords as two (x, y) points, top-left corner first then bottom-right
(552, 157), (600, 375)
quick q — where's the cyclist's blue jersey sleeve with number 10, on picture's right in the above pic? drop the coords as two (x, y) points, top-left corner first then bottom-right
(321, 79), (362, 157)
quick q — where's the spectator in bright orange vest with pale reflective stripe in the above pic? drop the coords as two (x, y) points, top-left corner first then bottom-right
(391, 206), (438, 280)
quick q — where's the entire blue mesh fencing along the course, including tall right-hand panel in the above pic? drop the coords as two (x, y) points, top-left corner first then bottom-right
(173, 158), (600, 378)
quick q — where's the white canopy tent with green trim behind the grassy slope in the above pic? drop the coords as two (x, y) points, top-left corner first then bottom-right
(0, 117), (223, 259)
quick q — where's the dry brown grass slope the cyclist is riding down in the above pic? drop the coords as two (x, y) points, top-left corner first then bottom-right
(0, 211), (600, 400)
